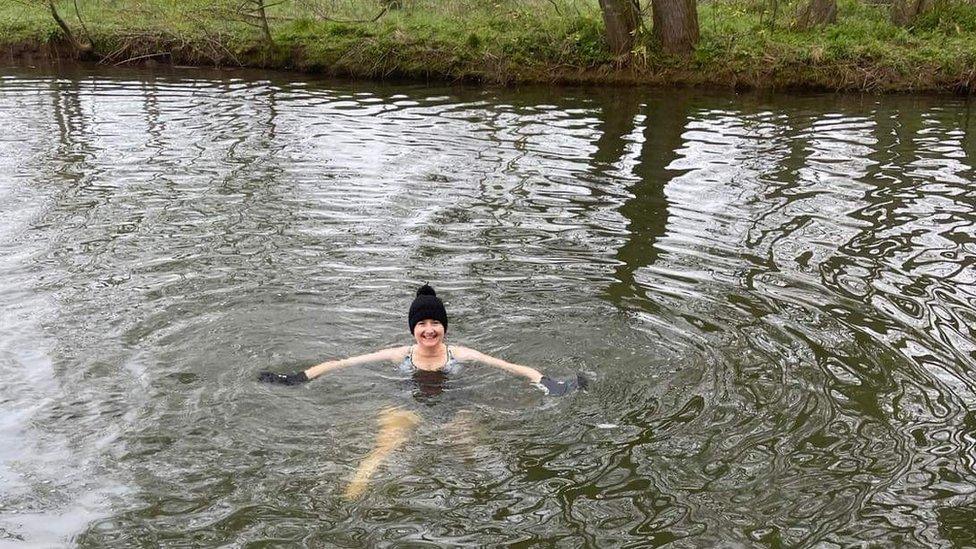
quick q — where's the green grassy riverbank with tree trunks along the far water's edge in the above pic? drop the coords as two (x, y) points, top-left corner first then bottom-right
(0, 0), (976, 93)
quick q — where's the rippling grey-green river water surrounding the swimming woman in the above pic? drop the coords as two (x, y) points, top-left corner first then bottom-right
(0, 68), (976, 547)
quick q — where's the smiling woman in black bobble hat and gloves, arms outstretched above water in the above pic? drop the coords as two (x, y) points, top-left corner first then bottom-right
(258, 284), (584, 396)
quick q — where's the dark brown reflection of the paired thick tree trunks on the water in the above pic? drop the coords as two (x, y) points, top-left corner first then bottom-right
(608, 94), (690, 307)
